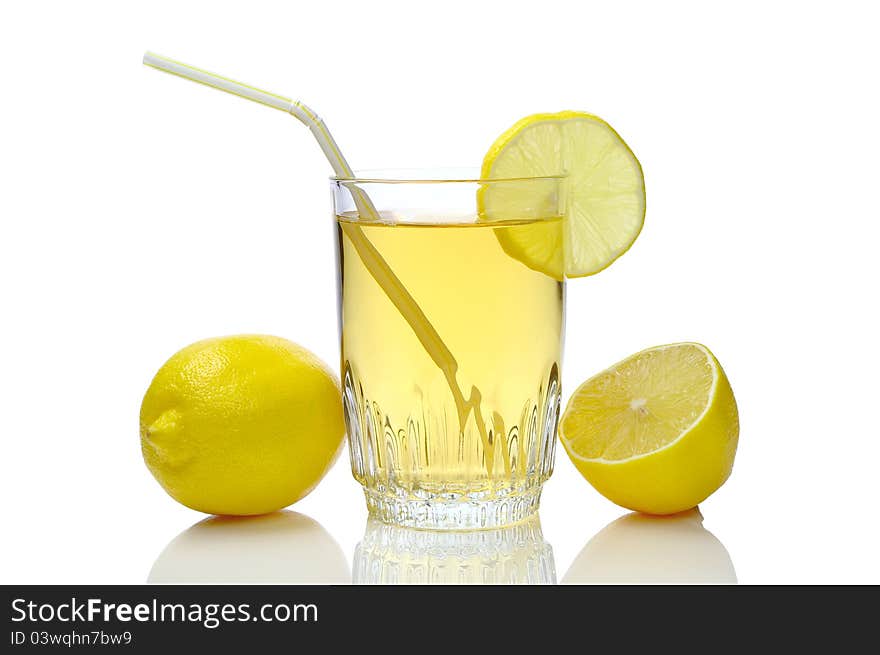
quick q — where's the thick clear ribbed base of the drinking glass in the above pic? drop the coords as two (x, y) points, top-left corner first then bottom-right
(364, 486), (541, 530)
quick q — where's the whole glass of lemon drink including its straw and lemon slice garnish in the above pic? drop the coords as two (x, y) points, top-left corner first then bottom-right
(144, 53), (645, 529)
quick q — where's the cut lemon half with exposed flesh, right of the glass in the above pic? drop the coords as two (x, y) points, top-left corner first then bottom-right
(559, 343), (739, 514)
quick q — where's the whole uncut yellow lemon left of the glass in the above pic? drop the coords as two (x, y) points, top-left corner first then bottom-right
(140, 335), (344, 515)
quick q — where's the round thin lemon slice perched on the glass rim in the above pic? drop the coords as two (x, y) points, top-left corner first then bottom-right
(478, 111), (645, 279)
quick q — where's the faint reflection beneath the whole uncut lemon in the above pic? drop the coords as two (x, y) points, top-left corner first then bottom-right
(147, 512), (350, 584)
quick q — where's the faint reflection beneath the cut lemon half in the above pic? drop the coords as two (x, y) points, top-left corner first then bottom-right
(562, 509), (736, 584)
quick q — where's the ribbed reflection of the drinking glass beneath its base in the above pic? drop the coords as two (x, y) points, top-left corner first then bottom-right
(353, 516), (556, 584)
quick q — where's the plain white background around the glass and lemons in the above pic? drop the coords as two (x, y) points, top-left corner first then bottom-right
(0, 0), (880, 583)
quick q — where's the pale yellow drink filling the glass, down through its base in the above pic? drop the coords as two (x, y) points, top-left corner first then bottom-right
(337, 215), (564, 527)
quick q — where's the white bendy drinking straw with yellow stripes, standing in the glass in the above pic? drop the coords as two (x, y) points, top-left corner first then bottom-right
(144, 52), (492, 452)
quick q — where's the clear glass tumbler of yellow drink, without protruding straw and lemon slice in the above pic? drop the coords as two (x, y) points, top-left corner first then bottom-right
(331, 171), (564, 529)
